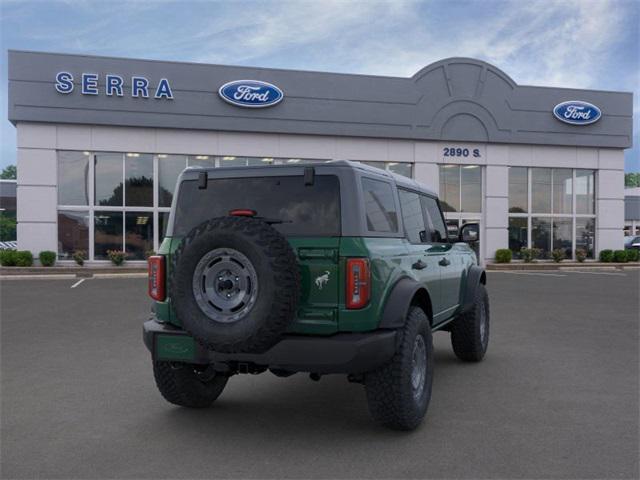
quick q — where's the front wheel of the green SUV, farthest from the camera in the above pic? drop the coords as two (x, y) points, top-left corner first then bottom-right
(451, 284), (489, 362)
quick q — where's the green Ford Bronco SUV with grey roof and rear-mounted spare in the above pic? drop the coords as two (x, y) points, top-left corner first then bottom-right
(144, 161), (489, 430)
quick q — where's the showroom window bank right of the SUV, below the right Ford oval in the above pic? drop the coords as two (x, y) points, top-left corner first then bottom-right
(509, 167), (596, 259)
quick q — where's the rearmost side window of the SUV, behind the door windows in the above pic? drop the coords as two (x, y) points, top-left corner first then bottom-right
(362, 178), (398, 233)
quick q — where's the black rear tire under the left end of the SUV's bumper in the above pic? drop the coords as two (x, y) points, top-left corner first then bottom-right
(153, 362), (228, 408)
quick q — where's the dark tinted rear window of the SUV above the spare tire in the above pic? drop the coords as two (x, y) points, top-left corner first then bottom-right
(173, 175), (340, 237)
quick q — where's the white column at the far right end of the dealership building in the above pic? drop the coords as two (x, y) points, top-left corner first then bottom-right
(596, 149), (624, 253)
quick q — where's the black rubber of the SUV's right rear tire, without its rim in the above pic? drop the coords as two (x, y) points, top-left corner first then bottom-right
(365, 306), (433, 430)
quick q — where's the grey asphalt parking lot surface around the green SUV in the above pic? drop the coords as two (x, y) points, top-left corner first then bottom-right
(0, 270), (640, 478)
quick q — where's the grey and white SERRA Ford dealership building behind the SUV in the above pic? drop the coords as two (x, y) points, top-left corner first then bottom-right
(8, 51), (632, 262)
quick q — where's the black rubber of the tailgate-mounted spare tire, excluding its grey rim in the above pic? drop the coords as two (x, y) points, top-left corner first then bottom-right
(169, 217), (300, 353)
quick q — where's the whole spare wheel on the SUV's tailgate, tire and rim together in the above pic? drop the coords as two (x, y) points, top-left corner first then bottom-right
(169, 217), (300, 353)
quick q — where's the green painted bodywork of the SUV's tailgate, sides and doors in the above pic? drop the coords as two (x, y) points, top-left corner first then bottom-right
(155, 237), (475, 335)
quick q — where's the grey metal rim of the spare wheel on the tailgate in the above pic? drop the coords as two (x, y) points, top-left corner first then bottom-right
(193, 248), (258, 323)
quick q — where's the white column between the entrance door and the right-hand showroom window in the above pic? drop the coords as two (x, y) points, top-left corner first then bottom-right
(480, 165), (509, 261)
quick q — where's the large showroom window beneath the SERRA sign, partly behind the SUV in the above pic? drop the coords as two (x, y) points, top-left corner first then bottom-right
(57, 150), (330, 261)
